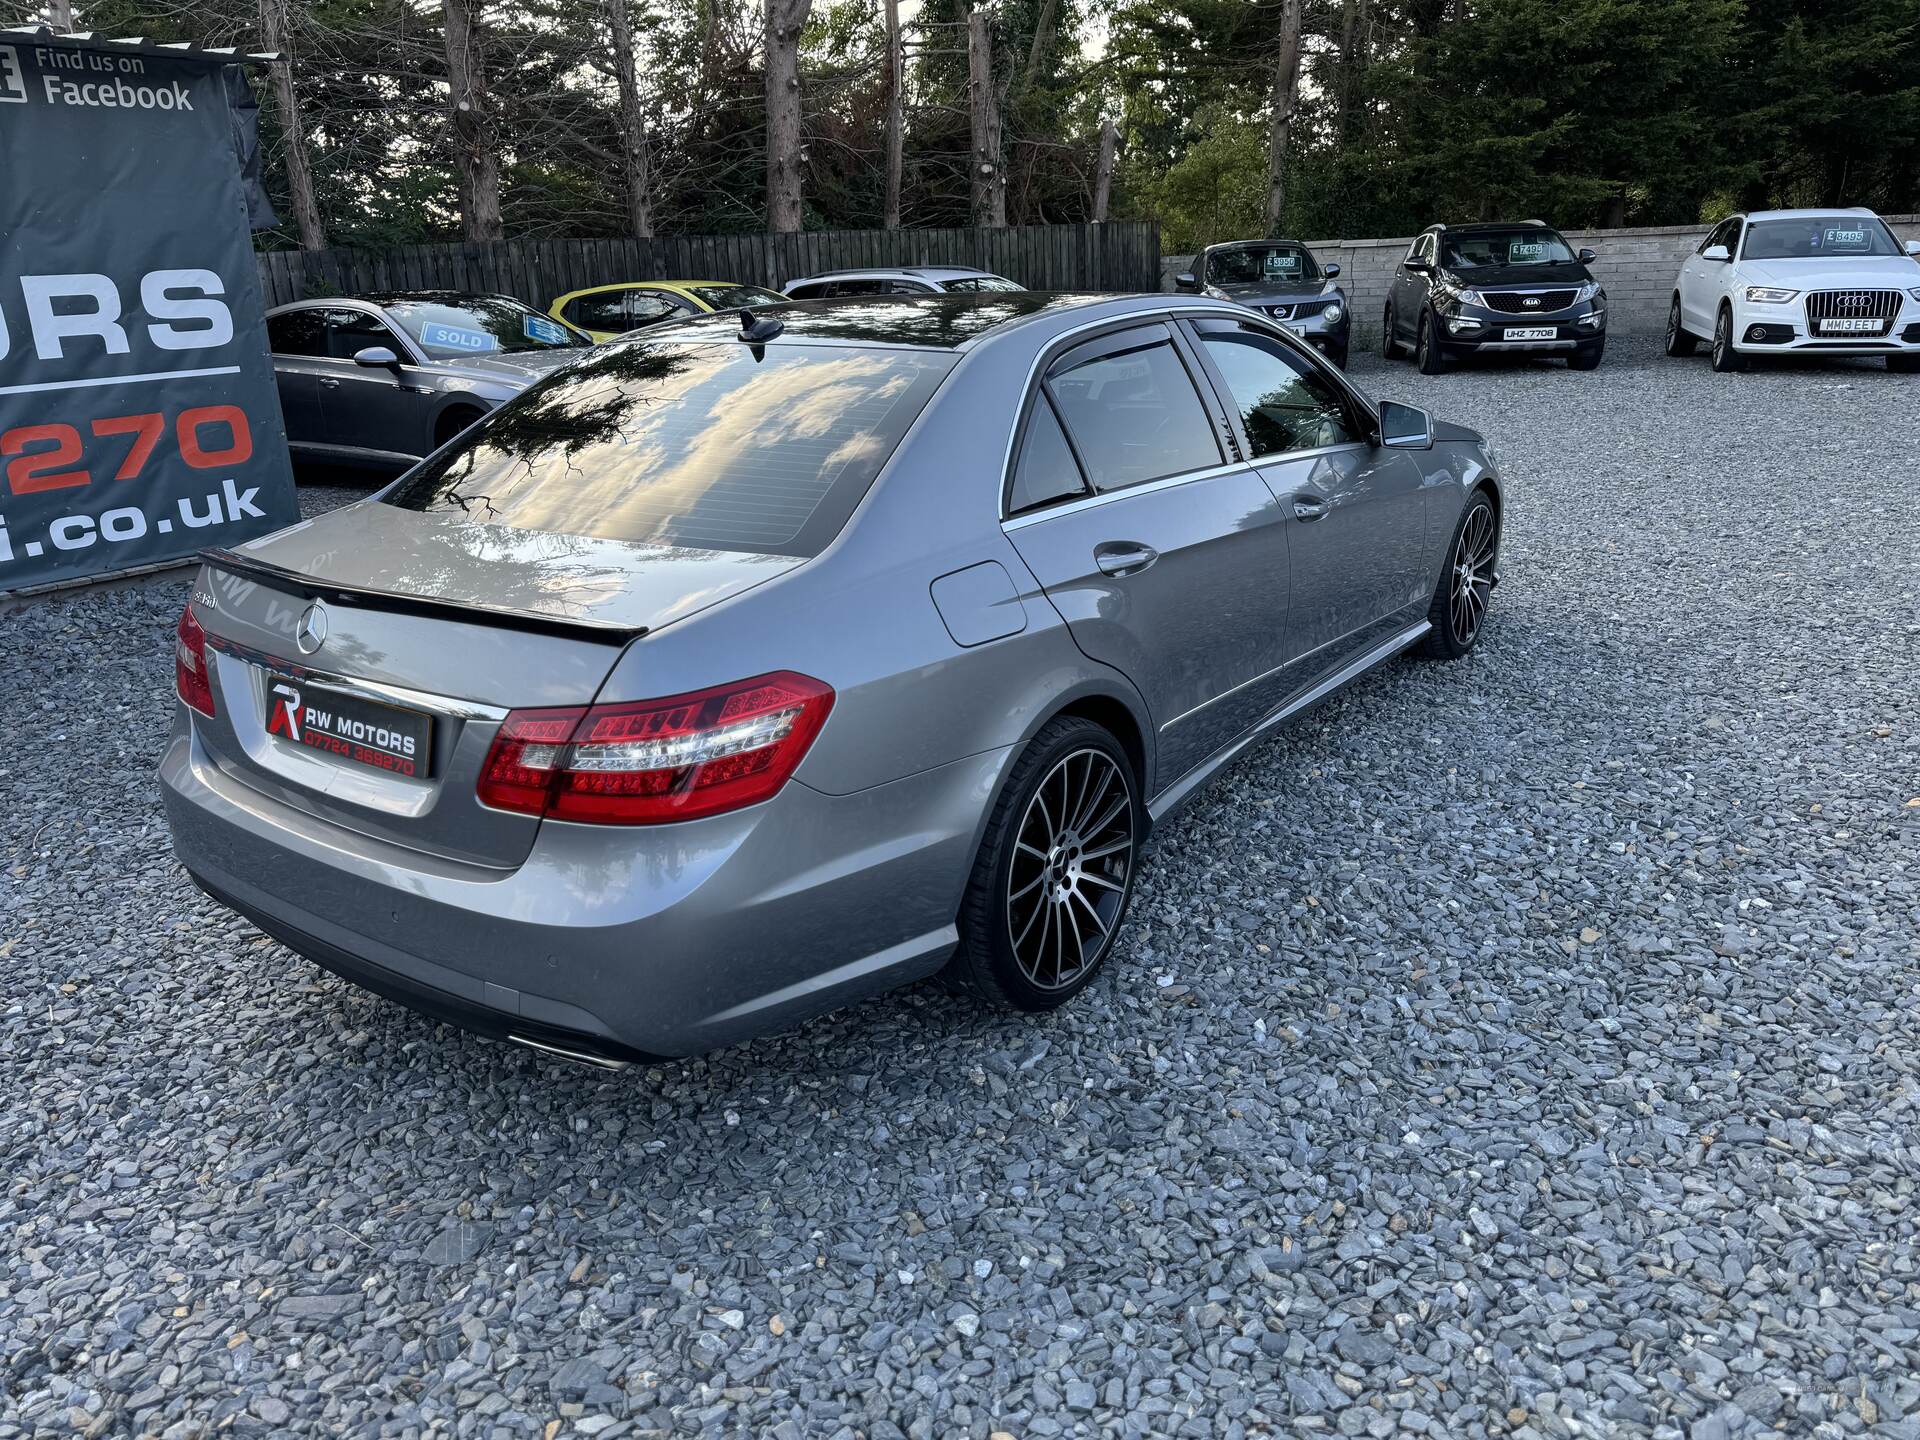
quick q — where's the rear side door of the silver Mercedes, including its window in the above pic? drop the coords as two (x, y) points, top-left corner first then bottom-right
(1008, 321), (1290, 783)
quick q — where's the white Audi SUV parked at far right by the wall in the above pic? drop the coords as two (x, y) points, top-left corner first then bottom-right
(1667, 209), (1920, 372)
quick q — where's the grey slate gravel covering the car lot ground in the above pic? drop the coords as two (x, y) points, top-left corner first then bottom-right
(0, 342), (1920, 1440)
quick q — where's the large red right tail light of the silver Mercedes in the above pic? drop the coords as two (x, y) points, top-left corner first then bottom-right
(480, 670), (833, 826)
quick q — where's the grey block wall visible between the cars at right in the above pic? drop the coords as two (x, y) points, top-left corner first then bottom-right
(1160, 215), (1920, 346)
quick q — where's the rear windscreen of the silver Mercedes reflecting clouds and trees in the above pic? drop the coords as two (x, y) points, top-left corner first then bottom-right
(382, 340), (958, 555)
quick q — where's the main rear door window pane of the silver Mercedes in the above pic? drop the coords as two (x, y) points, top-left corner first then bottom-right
(1046, 340), (1221, 490)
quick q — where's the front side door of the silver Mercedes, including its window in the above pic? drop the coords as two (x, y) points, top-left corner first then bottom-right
(1188, 317), (1432, 689)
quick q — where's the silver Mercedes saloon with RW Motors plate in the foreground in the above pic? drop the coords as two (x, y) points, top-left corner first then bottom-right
(161, 294), (1503, 1066)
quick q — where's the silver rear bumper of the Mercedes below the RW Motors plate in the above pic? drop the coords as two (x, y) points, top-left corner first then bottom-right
(159, 724), (1008, 1062)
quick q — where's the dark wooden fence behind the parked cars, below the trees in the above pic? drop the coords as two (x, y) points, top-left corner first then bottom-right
(257, 221), (1160, 309)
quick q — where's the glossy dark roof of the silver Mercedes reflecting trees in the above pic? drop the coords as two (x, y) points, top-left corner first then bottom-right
(612, 290), (1198, 351)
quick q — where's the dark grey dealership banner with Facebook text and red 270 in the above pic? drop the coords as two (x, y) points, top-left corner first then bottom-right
(0, 42), (298, 591)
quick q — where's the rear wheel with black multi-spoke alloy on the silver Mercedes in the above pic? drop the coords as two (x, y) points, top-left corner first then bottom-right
(945, 716), (1146, 1012)
